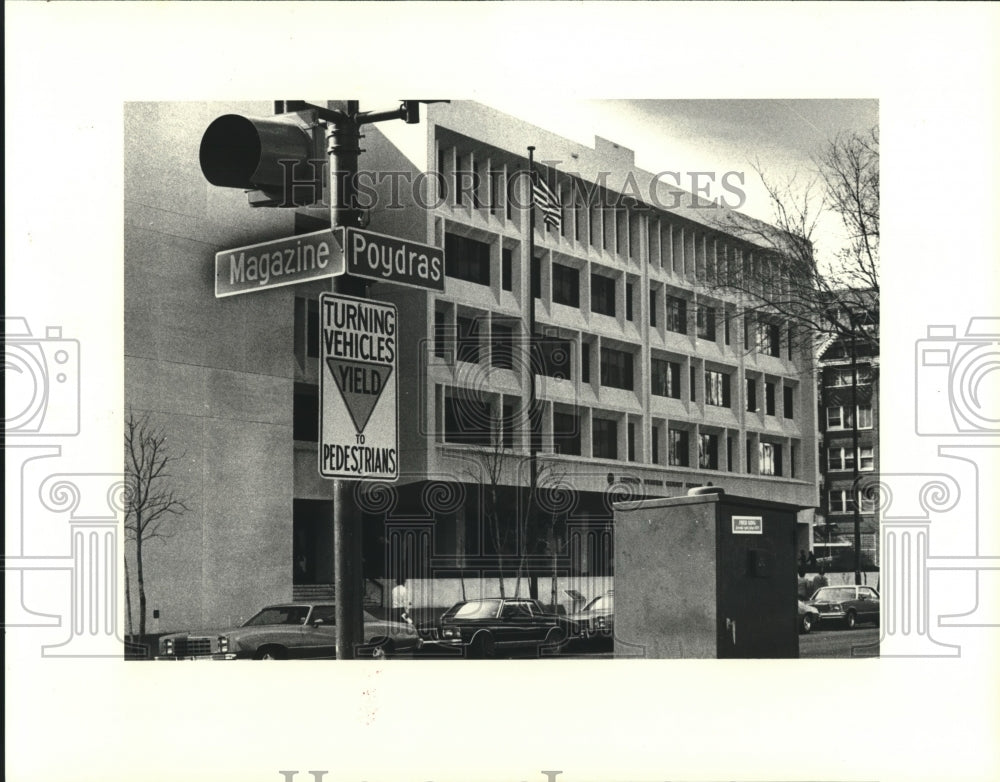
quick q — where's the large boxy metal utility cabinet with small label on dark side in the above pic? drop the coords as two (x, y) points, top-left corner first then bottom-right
(615, 487), (802, 658)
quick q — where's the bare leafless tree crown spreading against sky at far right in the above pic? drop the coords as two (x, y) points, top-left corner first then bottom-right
(706, 128), (879, 348)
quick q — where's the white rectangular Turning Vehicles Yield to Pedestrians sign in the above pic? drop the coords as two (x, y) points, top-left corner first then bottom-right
(319, 293), (399, 481)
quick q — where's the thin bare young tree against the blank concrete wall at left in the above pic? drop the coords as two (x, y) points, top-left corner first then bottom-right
(125, 410), (189, 636)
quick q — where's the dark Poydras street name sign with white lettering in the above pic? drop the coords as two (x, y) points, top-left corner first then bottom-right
(344, 228), (444, 292)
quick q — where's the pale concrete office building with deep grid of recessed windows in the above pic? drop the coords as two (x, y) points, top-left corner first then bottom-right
(125, 102), (817, 632)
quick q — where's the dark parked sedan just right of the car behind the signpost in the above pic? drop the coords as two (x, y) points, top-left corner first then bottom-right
(438, 597), (579, 657)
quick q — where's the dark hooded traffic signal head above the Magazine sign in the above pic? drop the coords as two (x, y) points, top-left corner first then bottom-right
(199, 111), (327, 207)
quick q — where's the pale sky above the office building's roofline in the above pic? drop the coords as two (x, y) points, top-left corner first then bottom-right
(379, 95), (879, 272)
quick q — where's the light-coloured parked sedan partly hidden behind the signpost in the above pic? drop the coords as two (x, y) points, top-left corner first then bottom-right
(157, 603), (421, 660)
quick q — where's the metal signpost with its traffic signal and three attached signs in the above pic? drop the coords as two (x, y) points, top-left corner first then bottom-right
(199, 100), (444, 659)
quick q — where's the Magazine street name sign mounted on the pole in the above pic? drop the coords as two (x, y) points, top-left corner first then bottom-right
(215, 228), (344, 299)
